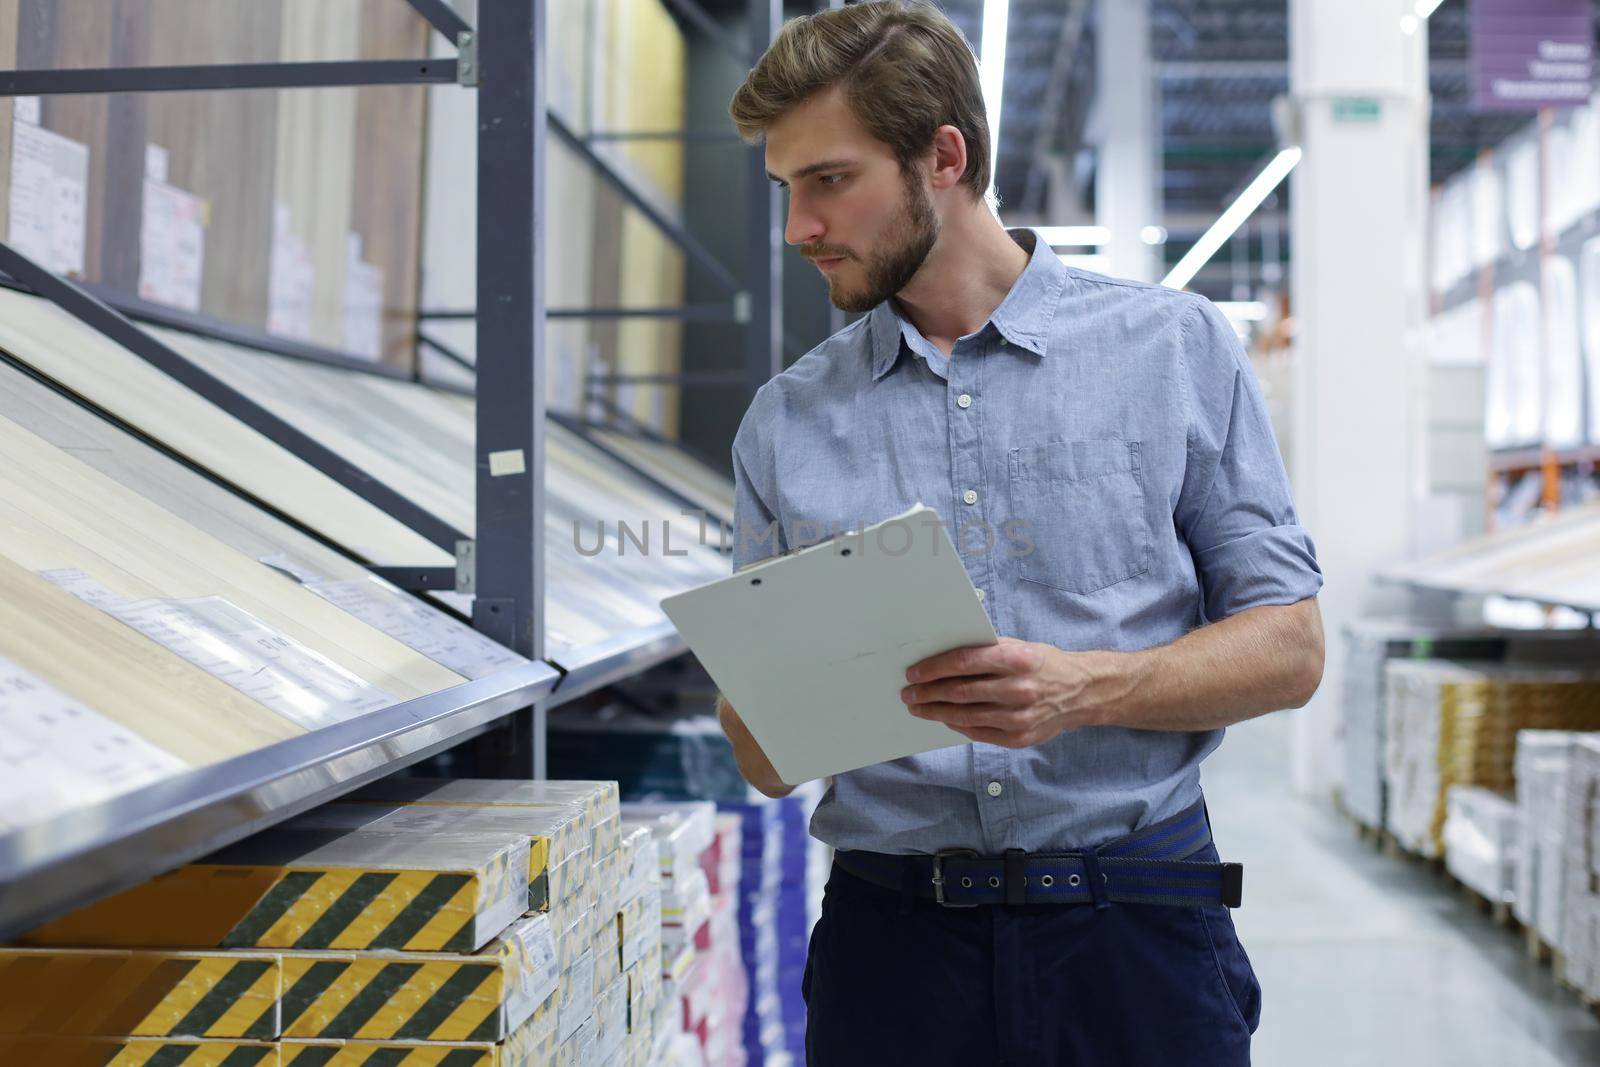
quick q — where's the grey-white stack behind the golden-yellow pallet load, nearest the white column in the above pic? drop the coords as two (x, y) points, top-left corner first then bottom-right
(1339, 619), (1506, 830)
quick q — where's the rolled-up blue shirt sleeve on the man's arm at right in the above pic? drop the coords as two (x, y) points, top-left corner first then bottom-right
(1174, 301), (1322, 622)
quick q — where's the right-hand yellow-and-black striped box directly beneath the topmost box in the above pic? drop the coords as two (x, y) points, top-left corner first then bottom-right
(283, 915), (560, 1041)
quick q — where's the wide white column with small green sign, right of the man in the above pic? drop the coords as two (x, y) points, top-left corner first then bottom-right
(1290, 0), (1429, 795)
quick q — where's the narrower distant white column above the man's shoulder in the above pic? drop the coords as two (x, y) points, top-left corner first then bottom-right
(1094, 0), (1162, 282)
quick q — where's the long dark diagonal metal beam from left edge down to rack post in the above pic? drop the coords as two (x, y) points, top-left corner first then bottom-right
(0, 243), (466, 555)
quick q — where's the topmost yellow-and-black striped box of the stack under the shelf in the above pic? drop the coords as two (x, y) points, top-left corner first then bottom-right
(22, 830), (528, 952)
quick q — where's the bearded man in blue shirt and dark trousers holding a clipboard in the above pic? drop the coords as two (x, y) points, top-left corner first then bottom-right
(718, 2), (1323, 1067)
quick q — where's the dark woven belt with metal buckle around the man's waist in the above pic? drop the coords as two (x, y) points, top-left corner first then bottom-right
(834, 801), (1245, 907)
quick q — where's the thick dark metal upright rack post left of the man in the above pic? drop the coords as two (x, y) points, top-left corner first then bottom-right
(472, 0), (555, 777)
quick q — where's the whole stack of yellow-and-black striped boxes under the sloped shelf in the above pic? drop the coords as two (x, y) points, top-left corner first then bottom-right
(0, 779), (630, 1067)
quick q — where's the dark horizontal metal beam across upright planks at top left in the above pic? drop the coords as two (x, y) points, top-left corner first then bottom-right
(0, 59), (456, 96)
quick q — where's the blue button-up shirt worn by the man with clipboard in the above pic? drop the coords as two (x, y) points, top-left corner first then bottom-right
(733, 230), (1322, 854)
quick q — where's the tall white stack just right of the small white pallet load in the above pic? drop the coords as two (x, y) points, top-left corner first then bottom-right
(1512, 729), (1584, 949)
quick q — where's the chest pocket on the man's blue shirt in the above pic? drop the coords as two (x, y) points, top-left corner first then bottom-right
(1008, 440), (1150, 593)
